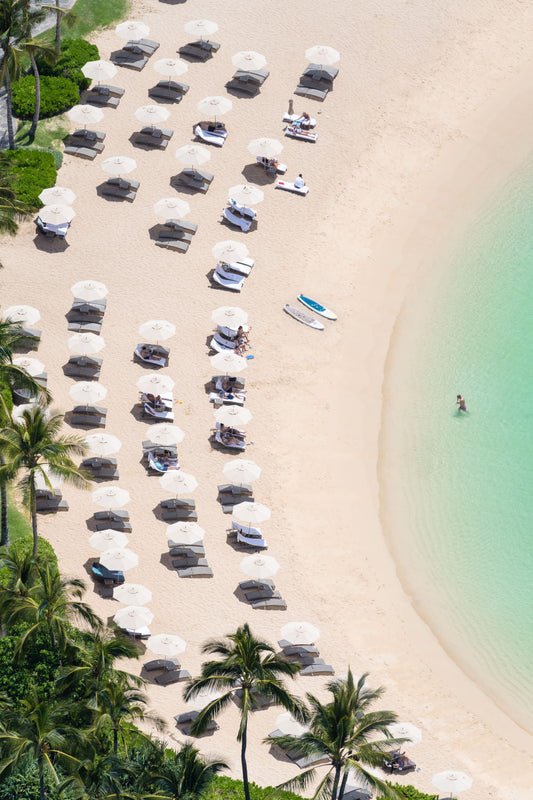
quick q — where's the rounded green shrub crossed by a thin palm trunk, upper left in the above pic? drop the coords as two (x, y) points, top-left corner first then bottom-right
(13, 75), (80, 119)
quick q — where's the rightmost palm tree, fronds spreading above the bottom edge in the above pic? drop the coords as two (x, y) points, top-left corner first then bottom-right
(264, 670), (404, 800)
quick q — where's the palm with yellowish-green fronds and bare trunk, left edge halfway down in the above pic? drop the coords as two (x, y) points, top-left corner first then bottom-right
(0, 405), (89, 556)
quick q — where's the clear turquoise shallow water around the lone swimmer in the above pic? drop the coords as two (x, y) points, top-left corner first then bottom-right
(381, 156), (533, 732)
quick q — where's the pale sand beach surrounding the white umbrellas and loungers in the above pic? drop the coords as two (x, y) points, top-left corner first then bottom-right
(0, 0), (533, 800)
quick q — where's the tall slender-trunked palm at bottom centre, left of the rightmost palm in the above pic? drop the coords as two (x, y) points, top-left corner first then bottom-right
(184, 623), (305, 800)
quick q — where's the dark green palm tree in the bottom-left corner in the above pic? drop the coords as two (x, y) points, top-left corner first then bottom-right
(0, 690), (85, 800)
